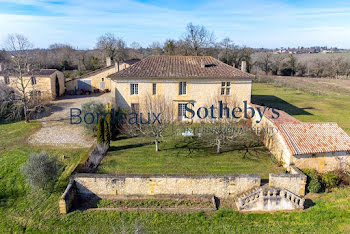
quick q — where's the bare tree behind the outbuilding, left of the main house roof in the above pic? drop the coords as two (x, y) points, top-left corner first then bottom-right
(96, 33), (126, 61)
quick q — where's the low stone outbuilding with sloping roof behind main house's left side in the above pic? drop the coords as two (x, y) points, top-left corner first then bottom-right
(66, 57), (140, 92)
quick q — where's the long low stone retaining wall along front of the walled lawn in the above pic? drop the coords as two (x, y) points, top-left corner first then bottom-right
(74, 174), (261, 198)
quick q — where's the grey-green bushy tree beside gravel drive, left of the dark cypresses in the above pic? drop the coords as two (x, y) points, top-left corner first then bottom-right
(81, 101), (106, 135)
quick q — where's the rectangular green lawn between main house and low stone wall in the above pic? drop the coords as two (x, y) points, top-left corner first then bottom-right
(98, 134), (283, 178)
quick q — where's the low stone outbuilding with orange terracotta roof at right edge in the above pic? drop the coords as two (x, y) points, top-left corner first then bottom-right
(252, 105), (350, 172)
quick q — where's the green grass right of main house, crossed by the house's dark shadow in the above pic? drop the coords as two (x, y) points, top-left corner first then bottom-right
(252, 82), (350, 134)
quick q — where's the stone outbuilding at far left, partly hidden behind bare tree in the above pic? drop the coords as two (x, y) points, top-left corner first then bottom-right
(0, 69), (65, 98)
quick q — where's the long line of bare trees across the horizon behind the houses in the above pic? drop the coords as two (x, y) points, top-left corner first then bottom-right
(0, 23), (350, 78)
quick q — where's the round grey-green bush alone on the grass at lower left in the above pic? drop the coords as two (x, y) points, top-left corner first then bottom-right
(22, 152), (63, 189)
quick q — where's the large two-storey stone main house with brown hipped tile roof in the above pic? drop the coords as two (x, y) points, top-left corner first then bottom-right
(109, 56), (254, 120)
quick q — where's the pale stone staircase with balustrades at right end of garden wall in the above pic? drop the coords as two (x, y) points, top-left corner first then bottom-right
(236, 185), (305, 211)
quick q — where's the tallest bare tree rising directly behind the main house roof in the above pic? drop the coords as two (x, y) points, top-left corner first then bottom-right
(184, 23), (214, 56)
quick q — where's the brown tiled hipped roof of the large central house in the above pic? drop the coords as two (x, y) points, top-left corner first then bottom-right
(109, 56), (254, 79)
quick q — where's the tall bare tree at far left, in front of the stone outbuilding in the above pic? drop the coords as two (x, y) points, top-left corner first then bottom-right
(6, 34), (33, 123)
